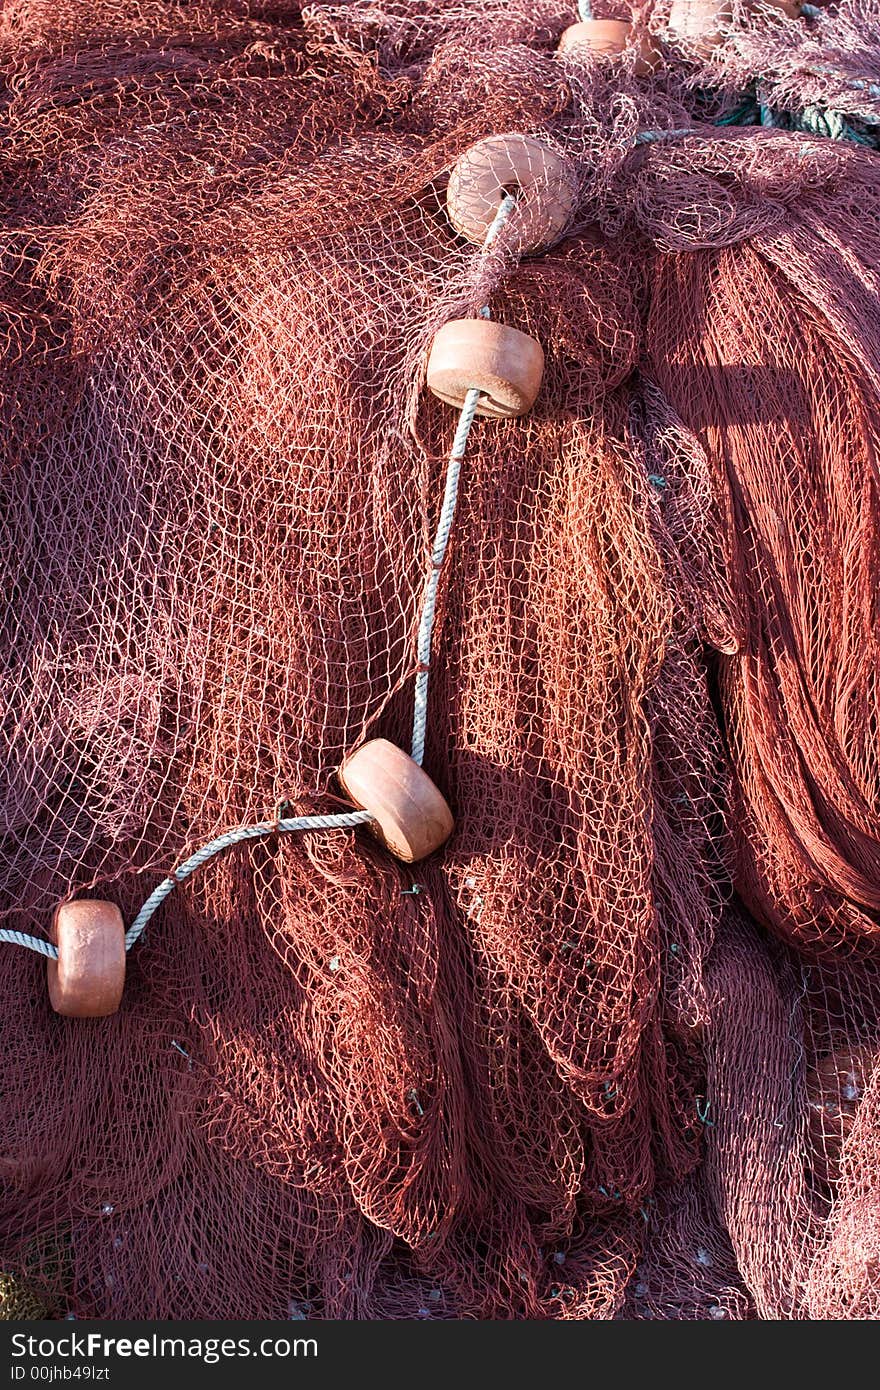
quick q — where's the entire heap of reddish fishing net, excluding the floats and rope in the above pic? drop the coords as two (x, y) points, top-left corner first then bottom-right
(0, 0), (880, 1319)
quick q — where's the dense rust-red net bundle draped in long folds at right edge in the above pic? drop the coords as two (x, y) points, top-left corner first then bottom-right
(648, 156), (880, 949)
